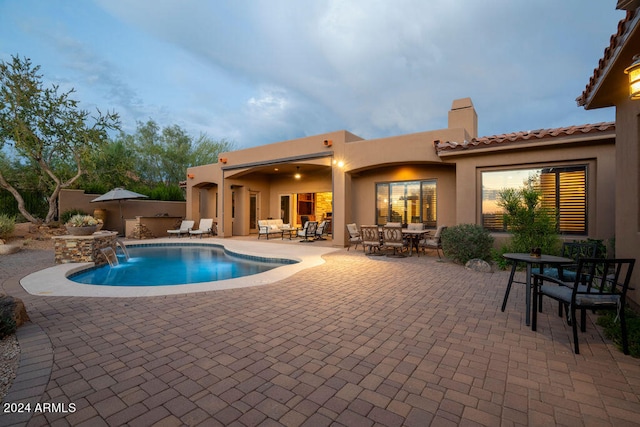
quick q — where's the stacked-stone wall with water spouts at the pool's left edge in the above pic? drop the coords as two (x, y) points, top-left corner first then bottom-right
(53, 232), (118, 265)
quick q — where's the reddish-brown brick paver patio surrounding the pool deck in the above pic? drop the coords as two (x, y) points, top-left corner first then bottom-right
(0, 244), (640, 427)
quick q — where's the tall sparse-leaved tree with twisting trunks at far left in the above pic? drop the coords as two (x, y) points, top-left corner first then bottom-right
(0, 55), (119, 224)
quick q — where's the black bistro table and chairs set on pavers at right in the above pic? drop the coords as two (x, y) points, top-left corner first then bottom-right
(501, 242), (635, 354)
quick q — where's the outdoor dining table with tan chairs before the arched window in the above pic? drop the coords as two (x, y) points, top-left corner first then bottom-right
(347, 222), (447, 258)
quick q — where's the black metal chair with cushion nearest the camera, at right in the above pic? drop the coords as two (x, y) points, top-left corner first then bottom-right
(531, 258), (635, 354)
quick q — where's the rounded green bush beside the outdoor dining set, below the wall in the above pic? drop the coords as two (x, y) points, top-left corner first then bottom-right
(442, 224), (493, 264)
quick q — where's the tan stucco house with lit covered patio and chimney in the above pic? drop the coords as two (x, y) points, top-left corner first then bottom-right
(186, 1), (640, 301)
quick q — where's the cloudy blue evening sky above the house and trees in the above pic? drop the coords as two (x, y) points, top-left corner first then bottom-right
(0, 0), (625, 148)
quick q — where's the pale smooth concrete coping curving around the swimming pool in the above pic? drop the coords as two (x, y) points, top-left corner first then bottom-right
(20, 238), (340, 298)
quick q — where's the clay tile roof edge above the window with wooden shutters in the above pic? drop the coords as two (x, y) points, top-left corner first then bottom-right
(434, 122), (616, 154)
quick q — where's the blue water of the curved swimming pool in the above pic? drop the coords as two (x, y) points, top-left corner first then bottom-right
(69, 245), (295, 286)
